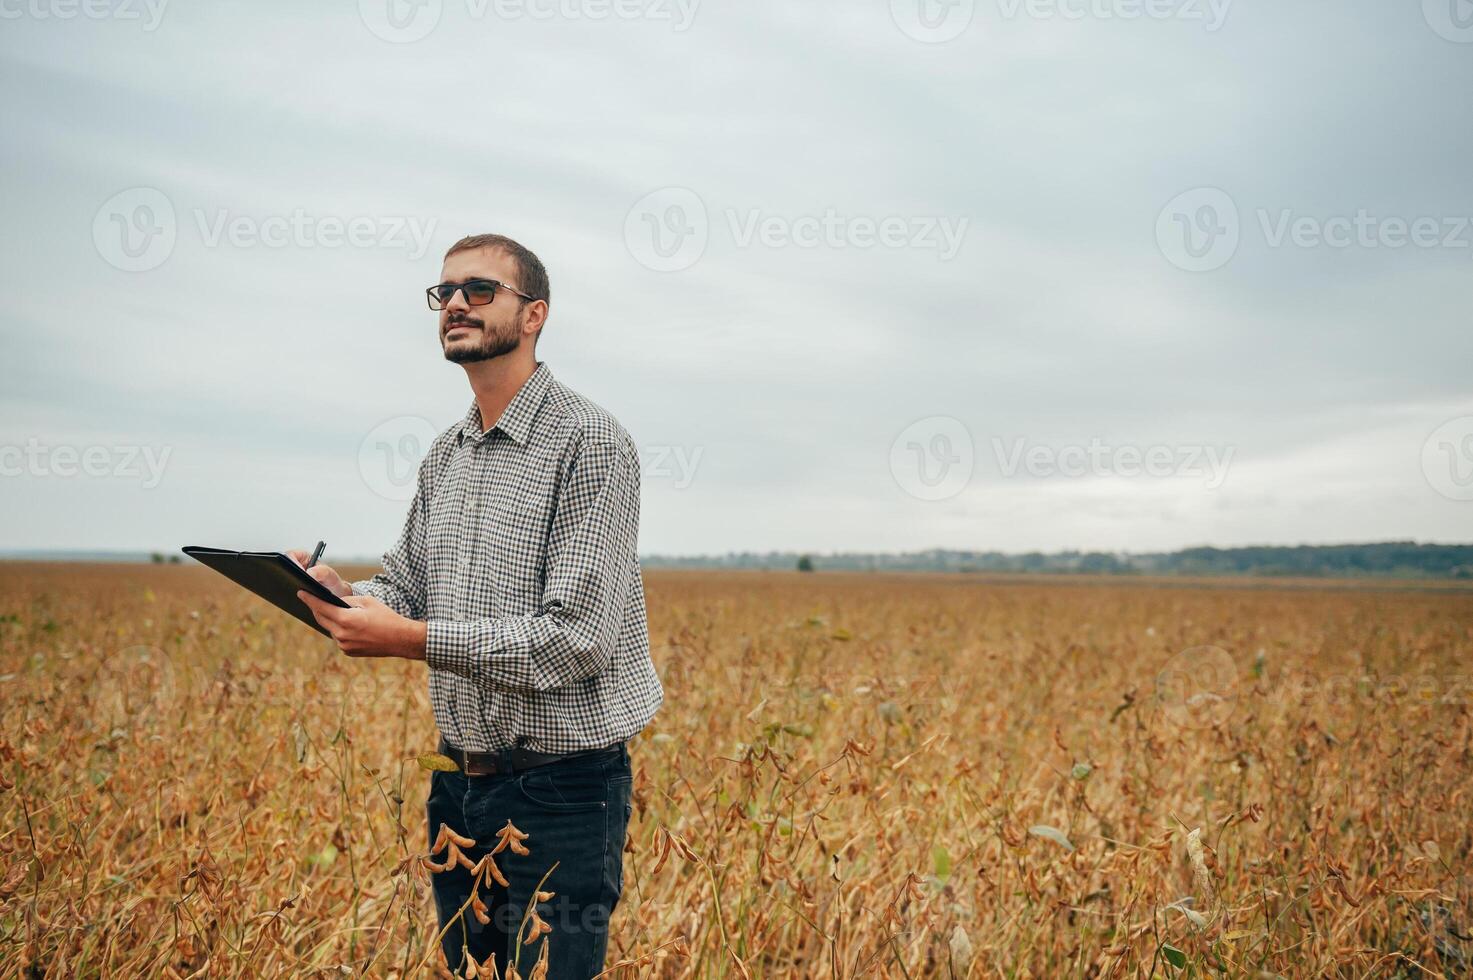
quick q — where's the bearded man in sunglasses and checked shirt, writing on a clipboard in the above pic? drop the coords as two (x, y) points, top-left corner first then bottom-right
(292, 234), (664, 980)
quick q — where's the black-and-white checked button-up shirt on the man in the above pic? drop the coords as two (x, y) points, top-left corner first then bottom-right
(352, 361), (664, 753)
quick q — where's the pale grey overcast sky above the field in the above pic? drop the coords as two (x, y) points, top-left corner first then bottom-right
(0, 0), (1473, 556)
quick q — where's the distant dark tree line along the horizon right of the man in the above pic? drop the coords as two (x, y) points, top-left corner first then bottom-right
(641, 541), (1473, 579)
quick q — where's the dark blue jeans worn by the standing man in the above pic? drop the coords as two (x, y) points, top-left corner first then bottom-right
(424, 743), (632, 980)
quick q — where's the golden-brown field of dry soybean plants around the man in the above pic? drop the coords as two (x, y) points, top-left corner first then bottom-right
(0, 564), (1473, 979)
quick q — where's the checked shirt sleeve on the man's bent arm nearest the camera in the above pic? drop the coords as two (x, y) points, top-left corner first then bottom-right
(426, 438), (639, 691)
